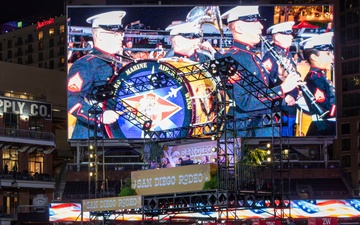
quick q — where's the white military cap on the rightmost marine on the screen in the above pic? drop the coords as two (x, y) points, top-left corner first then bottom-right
(300, 32), (334, 51)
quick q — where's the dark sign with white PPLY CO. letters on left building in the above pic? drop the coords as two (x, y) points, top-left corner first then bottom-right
(0, 97), (52, 120)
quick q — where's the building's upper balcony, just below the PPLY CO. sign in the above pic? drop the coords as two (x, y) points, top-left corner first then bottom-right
(0, 127), (55, 146)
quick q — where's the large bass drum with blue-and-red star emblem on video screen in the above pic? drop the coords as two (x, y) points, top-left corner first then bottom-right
(104, 59), (221, 139)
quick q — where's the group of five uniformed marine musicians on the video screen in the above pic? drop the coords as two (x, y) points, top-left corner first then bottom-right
(68, 6), (336, 139)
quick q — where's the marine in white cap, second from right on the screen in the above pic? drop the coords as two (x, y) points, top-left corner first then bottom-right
(263, 21), (299, 136)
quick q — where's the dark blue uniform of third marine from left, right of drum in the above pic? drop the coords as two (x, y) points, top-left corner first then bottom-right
(224, 42), (284, 137)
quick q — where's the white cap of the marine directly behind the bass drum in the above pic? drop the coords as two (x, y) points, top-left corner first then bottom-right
(165, 21), (202, 38)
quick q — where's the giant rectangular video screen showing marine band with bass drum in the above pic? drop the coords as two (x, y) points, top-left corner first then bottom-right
(67, 5), (336, 140)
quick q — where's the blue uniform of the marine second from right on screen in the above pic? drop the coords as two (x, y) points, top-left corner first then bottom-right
(263, 45), (299, 136)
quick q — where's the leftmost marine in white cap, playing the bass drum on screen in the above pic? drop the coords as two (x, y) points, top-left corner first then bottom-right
(68, 11), (126, 139)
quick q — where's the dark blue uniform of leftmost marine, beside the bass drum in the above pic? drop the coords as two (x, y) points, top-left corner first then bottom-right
(68, 50), (119, 139)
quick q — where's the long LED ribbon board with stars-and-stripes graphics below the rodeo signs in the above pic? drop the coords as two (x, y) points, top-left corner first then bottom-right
(49, 200), (360, 222)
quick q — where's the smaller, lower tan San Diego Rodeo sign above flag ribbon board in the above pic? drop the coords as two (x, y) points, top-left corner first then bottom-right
(83, 195), (141, 212)
